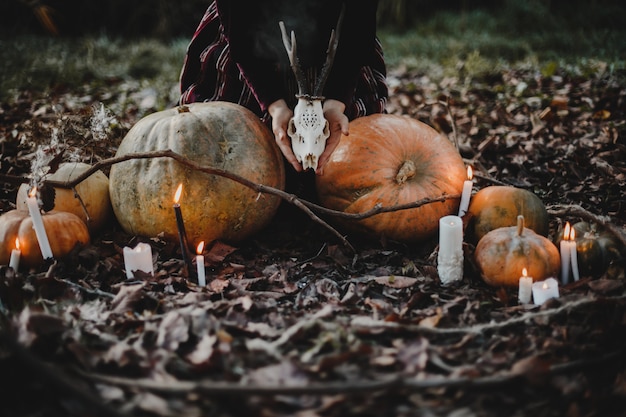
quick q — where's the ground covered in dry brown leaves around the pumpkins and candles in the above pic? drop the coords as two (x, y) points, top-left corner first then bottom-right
(0, 50), (626, 417)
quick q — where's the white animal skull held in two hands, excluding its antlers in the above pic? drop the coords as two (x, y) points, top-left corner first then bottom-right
(287, 97), (330, 170)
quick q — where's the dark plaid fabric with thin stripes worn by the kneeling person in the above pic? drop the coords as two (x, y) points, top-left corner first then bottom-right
(180, 1), (388, 121)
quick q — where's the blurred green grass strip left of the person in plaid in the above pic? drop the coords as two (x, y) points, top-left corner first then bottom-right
(0, 36), (188, 107)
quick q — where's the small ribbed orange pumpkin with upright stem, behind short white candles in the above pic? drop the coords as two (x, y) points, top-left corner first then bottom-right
(474, 216), (561, 287)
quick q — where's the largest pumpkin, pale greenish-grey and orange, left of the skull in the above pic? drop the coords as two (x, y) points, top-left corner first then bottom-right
(109, 102), (285, 247)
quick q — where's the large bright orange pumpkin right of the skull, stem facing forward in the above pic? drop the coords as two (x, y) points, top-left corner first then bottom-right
(316, 114), (467, 242)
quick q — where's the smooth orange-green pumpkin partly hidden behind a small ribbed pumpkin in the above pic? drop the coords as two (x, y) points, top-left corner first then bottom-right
(467, 185), (550, 242)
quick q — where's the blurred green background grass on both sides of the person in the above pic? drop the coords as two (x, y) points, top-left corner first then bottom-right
(0, 0), (626, 107)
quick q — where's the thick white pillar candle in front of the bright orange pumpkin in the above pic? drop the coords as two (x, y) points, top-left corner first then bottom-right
(437, 215), (463, 285)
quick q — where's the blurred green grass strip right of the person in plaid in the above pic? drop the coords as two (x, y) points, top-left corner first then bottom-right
(379, 0), (626, 76)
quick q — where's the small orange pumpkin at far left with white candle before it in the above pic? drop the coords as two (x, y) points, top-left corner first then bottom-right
(0, 210), (89, 266)
